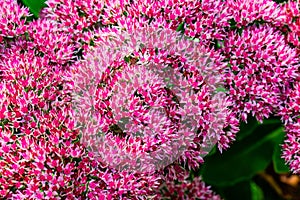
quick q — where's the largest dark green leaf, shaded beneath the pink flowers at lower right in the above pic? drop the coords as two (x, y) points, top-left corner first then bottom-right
(200, 125), (284, 186)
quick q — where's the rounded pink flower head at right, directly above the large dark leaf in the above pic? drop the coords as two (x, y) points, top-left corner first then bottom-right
(222, 26), (299, 121)
